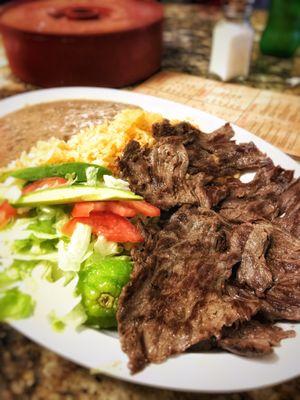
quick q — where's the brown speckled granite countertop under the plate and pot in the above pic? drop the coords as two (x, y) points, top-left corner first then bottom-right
(0, 4), (300, 400)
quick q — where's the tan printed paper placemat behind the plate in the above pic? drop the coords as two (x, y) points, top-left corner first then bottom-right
(134, 72), (300, 157)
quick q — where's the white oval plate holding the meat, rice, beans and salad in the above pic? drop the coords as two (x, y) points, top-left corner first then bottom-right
(0, 87), (300, 392)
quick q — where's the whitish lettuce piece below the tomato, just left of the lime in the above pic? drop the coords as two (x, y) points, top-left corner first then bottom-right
(57, 224), (92, 272)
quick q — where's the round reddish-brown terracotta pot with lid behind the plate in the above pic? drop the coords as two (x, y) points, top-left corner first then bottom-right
(0, 0), (163, 87)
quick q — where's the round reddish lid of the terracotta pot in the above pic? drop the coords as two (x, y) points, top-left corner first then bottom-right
(0, 0), (163, 35)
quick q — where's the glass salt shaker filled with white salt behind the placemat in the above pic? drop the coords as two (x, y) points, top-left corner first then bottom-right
(209, 0), (254, 81)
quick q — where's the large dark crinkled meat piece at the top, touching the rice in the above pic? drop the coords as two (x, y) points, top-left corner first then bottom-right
(119, 121), (272, 209)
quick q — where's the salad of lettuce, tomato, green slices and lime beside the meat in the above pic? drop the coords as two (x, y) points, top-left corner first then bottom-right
(0, 162), (160, 331)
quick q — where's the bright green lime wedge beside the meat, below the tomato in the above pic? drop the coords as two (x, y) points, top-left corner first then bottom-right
(78, 254), (131, 329)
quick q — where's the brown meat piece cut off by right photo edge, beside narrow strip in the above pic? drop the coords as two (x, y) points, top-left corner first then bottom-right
(262, 226), (300, 321)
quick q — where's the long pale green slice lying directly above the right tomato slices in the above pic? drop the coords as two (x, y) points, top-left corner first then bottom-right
(14, 185), (142, 207)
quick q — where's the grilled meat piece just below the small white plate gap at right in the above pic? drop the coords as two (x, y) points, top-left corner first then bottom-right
(220, 166), (293, 223)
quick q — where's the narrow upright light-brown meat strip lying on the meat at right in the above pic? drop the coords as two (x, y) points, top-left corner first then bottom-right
(237, 225), (273, 297)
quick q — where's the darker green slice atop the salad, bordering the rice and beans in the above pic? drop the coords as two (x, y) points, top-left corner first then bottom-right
(10, 162), (111, 182)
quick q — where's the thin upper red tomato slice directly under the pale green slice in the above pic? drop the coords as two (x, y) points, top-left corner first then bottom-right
(72, 200), (160, 218)
